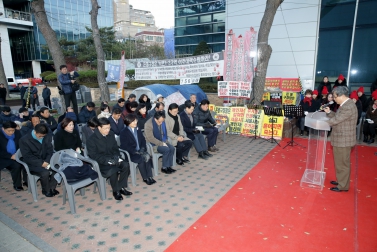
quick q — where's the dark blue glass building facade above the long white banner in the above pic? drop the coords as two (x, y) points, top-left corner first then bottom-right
(174, 0), (225, 57)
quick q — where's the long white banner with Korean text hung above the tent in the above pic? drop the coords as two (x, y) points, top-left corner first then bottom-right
(135, 53), (224, 80)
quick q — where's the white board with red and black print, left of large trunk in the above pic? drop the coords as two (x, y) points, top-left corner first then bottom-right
(217, 81), (251, 99)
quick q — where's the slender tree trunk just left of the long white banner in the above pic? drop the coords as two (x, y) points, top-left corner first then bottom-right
(90, 0), (110, 101)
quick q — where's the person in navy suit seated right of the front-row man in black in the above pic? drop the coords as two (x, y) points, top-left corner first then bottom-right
(120, 114), (156, 185)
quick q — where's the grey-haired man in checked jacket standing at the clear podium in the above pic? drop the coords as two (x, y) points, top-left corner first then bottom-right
(324, 86), (357, 192)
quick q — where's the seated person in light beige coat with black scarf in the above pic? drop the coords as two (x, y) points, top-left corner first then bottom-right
(165, 103), (192, 165)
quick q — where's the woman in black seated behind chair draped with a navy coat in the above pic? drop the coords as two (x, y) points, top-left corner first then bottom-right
(54, 118), (82, 153)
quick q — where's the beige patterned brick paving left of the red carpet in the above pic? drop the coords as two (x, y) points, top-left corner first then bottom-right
(0, 135), (275, 251)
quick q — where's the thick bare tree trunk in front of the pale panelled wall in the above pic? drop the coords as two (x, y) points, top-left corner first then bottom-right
(251, 0), (284, 105)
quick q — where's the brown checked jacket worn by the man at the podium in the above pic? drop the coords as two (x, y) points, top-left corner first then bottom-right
(327, 99), (357, 147)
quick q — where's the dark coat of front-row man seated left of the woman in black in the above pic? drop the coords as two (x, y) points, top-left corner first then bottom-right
(20, 133), (54, 170)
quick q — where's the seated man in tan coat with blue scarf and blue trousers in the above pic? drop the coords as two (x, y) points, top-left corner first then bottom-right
(144, 111), (176, 174)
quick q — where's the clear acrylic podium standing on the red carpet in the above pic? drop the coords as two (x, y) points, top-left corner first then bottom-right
(300, 112), (330, 190)
